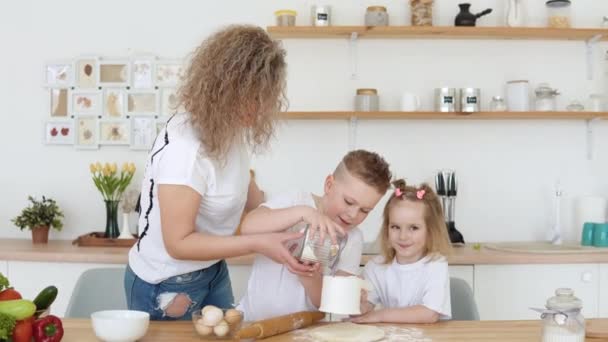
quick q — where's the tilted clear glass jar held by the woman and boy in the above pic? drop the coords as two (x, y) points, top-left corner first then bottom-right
(286, 222), (348, 267)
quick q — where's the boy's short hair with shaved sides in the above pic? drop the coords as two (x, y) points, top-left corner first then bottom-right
(334, 150), (392, 195)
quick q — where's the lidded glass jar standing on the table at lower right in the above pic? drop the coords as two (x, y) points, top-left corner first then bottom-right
(541, 288), (585, 342)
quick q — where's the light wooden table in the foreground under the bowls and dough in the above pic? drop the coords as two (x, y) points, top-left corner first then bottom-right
(62, 318), (608, 342)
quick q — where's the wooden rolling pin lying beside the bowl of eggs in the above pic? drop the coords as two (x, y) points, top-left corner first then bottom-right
(235, 311), (325, 339)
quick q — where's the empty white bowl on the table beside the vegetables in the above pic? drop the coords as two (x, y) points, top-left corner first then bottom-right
(91, 310), (150, 342)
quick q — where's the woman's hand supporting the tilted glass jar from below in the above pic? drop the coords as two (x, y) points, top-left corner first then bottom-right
(250, 232), (315, 275)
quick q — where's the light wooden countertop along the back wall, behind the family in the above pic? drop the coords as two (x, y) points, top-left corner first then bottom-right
(0, 239), (608, 265)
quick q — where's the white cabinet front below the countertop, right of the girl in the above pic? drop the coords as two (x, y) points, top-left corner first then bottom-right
(474, 264), (605, 320)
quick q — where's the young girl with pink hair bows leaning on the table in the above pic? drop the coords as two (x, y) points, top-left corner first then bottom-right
(351, 180), (452, 323)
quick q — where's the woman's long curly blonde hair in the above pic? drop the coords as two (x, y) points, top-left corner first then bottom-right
(176, 25), (287, 161)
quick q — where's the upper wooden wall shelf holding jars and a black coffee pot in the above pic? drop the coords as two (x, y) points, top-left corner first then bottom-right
(267, 26), (608, 41)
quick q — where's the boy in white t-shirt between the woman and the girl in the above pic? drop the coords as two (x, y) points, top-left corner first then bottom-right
(238, 150), (391, 321)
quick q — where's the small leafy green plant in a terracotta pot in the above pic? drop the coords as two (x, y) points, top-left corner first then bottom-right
(11, 196), (63, 244)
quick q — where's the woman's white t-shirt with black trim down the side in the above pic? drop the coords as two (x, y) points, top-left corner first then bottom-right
(129, 113), (250, 284)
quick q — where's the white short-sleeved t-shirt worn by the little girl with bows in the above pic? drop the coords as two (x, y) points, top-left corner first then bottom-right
(363, 256), (452, 319)
